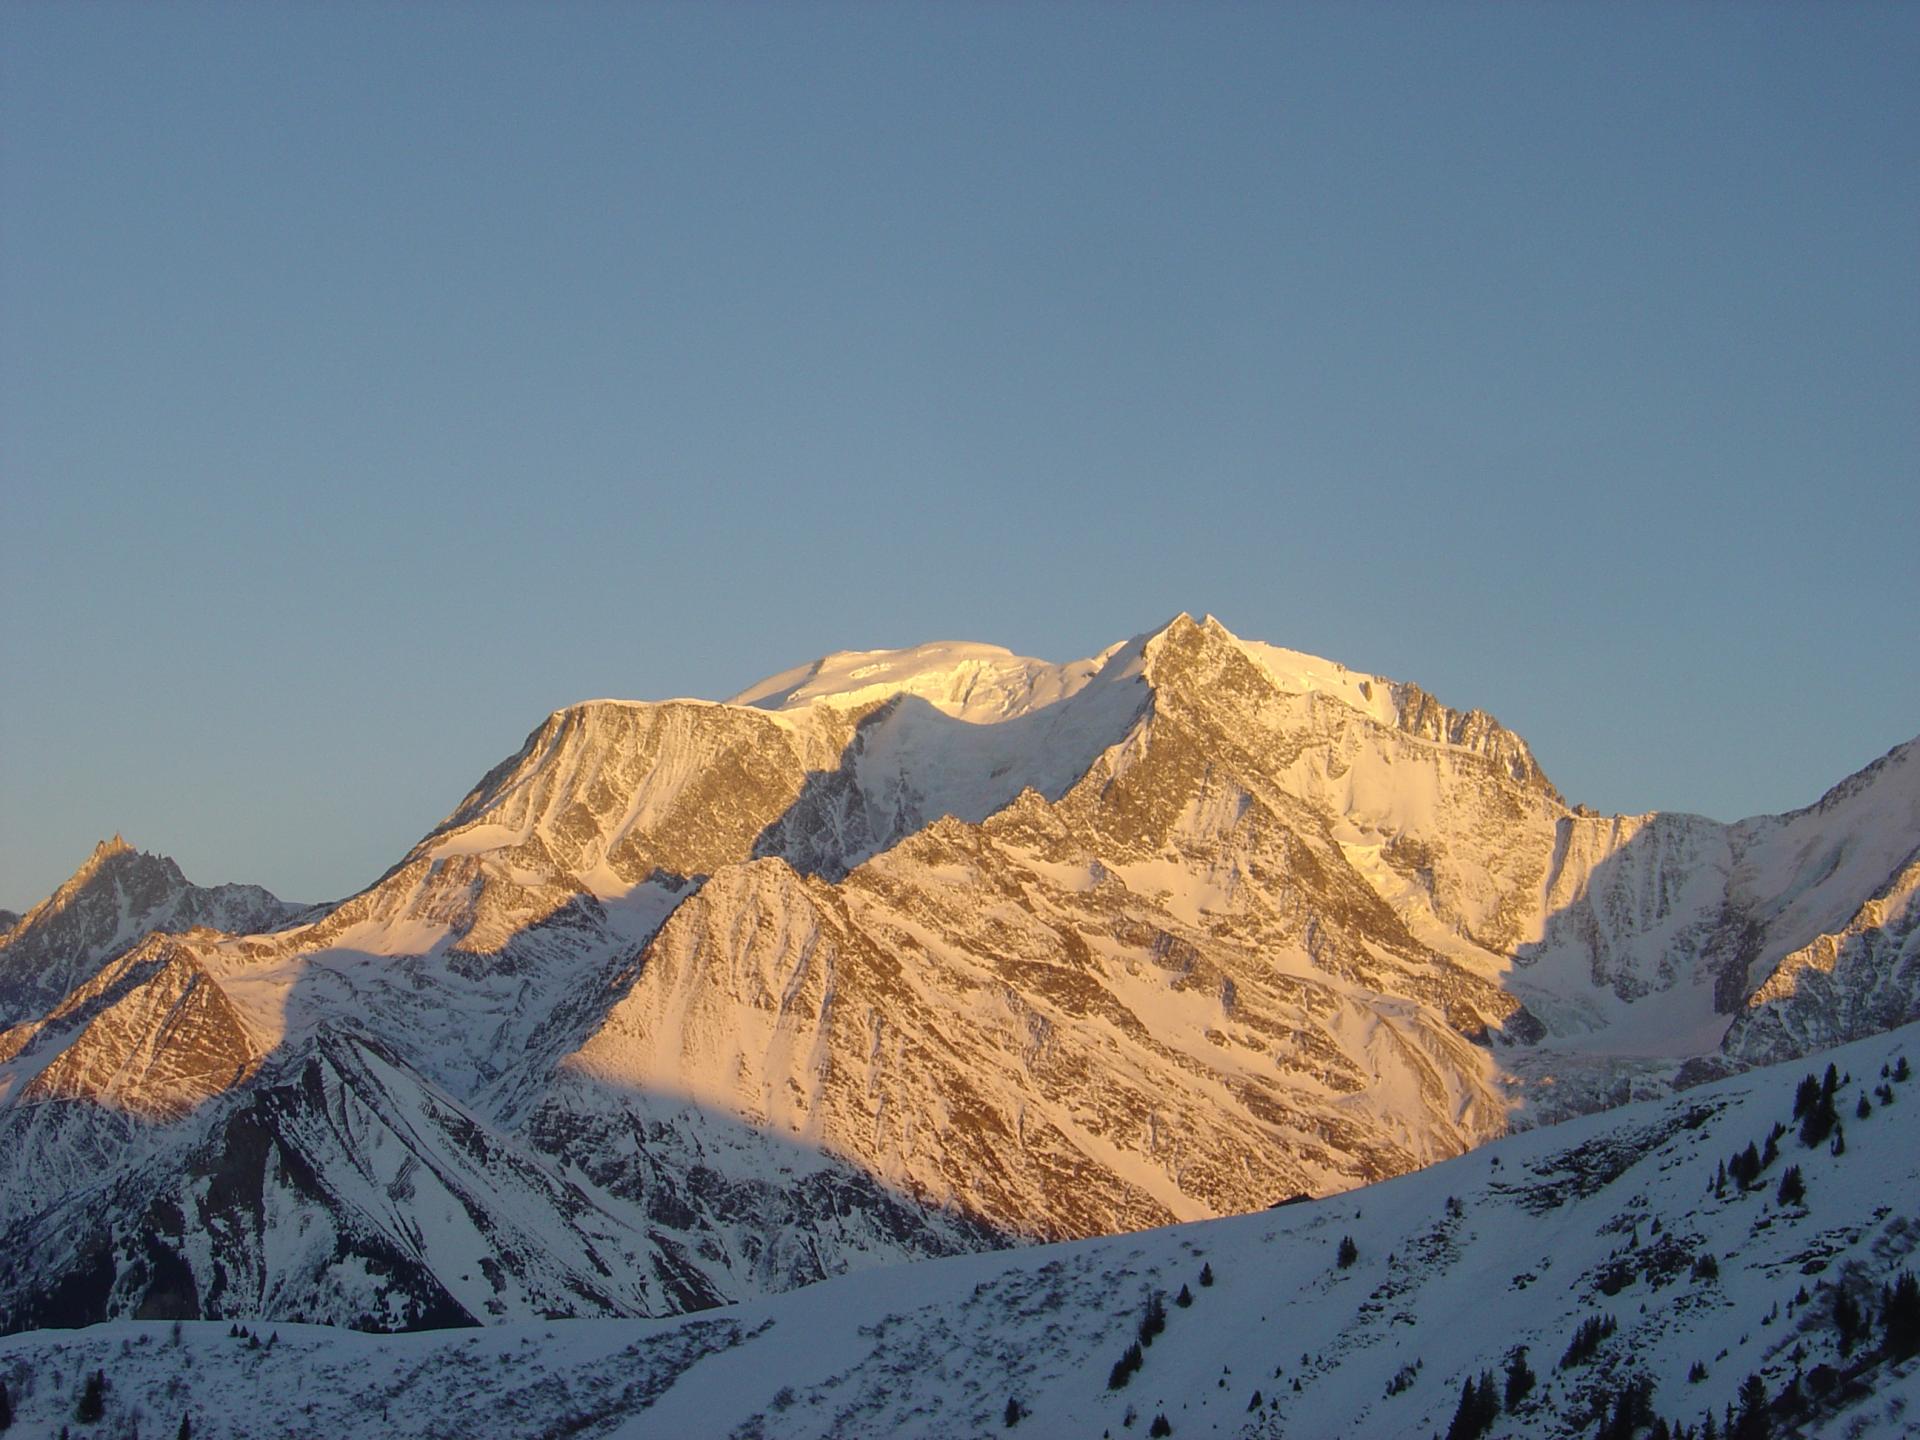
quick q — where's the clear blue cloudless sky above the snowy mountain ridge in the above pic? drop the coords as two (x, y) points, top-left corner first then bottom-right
(0, 0), (1920, 908)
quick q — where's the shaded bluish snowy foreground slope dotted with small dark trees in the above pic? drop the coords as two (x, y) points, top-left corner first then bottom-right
(0, 1027), (1920, 1440)
